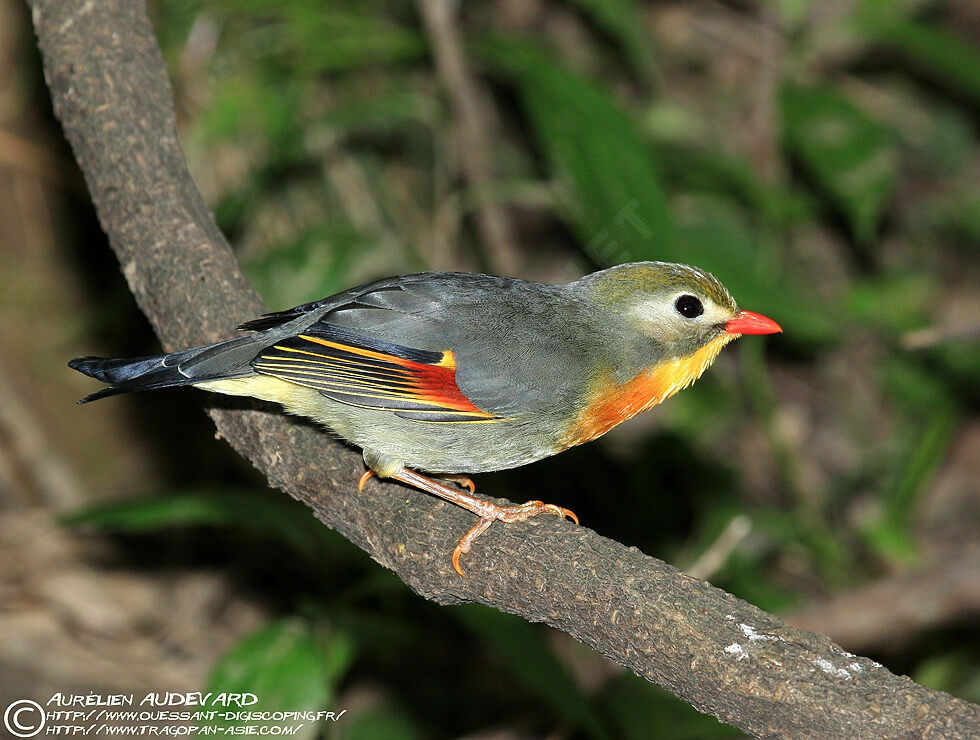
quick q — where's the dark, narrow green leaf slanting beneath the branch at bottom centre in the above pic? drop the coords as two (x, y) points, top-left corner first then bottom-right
(451, 604), (607, 738)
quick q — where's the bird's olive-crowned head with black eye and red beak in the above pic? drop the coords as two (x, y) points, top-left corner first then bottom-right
(583, 262), (782, 362)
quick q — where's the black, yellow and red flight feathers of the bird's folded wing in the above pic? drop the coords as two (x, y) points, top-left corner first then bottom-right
(252, 323), (502, 423)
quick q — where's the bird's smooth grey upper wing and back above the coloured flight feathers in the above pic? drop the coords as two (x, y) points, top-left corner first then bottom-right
(253, 273), (588, 418)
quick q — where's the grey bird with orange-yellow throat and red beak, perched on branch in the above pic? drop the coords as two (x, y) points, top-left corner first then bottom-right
(69, 262), (782, 575)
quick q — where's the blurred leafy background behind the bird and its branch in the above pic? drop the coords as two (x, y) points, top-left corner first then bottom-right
(0, 0), (980, 737)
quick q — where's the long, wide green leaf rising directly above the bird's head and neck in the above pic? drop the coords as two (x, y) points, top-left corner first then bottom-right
(481, 39), (673, 264)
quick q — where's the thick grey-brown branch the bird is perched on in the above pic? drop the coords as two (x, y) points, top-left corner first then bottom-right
(30, 0), (980, 737)
